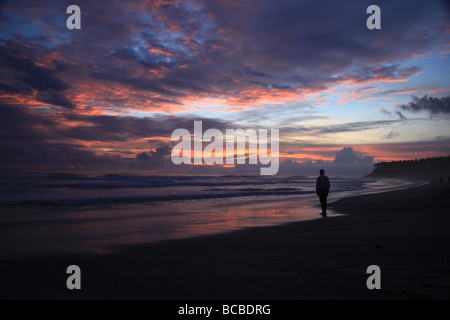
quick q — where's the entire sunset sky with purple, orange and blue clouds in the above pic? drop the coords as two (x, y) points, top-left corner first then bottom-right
(0, 0), (450, 174)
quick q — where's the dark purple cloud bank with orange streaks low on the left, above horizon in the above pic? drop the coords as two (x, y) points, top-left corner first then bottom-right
(0, 100), (233, 171)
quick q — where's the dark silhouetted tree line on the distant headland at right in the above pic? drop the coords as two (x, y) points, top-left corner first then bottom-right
(368, 156), (450, 182)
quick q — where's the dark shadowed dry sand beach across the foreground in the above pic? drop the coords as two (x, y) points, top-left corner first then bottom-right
(0, 183), (450, 300)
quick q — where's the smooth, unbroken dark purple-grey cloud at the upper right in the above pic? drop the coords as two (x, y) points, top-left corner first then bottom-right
(201, 1), (445, 74)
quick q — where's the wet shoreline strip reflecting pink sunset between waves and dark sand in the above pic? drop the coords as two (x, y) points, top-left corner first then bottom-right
(0, 179), (420, 261)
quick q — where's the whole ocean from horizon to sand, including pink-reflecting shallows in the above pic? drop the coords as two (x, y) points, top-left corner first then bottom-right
(0, 173), (411, 259)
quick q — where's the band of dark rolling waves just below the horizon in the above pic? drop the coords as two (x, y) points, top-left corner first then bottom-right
(0, 173), (377, 206)
